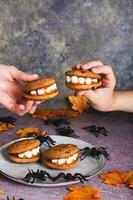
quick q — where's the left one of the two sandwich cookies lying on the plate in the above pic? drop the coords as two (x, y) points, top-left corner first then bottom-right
(7, 139), (40, 163)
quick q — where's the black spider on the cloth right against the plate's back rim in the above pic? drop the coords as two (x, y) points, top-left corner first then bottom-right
(55, 126), (79, 138)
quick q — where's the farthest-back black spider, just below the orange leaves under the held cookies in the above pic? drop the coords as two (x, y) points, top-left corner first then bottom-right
(44, 118), (70, 127)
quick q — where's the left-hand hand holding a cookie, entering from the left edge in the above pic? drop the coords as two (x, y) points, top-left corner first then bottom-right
(0, 65), (40, 115)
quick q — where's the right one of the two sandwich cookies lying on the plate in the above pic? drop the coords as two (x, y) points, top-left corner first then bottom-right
(43, 144), (80, 170)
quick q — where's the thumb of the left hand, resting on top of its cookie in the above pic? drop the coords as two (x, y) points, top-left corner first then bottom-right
(11, 68), (38, 82)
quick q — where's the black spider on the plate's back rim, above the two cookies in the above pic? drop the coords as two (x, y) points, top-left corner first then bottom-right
(28, 130), (56, 147)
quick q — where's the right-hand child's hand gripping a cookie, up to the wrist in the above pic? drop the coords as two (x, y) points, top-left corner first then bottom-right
(76, 61), (116, 111)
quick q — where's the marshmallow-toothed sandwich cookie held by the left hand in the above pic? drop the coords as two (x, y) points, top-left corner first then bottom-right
(22, 77), (58, 101)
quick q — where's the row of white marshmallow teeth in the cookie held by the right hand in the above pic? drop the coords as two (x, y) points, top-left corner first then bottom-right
(66, 76), (98, 85)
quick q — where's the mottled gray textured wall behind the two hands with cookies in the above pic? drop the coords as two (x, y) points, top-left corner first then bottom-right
(0, 0), (133, 107)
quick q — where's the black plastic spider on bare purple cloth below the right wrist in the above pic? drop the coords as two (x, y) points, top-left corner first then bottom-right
(82, 125), (108, 137)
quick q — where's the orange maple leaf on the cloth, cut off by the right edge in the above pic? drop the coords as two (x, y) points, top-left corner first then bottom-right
(100, 170), (133, 189)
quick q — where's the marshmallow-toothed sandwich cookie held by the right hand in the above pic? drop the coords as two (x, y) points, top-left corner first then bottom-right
(65, 68), (102, 90)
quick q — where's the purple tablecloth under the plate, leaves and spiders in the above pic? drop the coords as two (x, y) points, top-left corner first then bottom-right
(0, 110), (133, 200)
